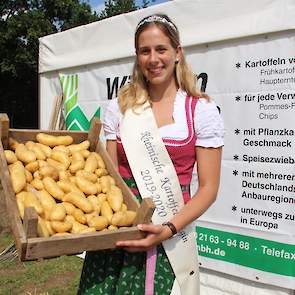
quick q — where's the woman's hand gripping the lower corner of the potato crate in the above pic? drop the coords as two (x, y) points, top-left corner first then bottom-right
(116, 224), (171, 252)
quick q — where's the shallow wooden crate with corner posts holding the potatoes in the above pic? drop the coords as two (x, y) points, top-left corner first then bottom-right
(0, 114), (155, 261)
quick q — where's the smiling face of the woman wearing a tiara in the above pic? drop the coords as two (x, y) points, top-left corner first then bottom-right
(137, 25), (181, 86)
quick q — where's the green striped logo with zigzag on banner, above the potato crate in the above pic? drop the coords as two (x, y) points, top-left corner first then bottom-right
(59, 74), (100, 131)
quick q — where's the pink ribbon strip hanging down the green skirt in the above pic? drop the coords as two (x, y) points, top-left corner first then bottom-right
(144, 247), (157, 295)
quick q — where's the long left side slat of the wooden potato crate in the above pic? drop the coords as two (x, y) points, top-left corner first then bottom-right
(0, 141), (27, 257)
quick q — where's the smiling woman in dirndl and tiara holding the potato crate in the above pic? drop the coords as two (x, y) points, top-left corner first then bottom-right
(78, 15), (223, 295)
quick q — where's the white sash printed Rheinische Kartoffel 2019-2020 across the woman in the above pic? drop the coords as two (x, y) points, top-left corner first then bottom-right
(120, 103), (200, 295)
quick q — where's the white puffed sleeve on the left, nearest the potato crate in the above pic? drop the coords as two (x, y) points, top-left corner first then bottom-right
(102, 98), (121, 140)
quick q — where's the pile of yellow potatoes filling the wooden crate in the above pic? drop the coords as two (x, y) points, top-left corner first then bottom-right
(4, 133), (136, 237)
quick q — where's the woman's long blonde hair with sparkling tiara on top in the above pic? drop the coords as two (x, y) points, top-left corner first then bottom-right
(118, 14), (208, 114)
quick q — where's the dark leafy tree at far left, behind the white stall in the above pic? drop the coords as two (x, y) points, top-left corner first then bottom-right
(0, 0), (98, 128)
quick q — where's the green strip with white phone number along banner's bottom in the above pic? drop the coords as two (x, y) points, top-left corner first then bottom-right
(196, 226), (295, 278)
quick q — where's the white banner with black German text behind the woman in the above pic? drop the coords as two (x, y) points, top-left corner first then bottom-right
(51, 31), (295, 289)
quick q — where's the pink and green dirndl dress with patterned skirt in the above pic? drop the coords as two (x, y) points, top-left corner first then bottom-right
(78, 97), (198, 295)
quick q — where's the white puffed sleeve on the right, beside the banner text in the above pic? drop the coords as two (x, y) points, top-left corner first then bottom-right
(194, 98), (224, 148)
